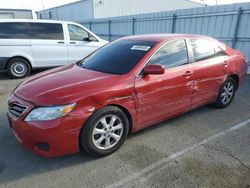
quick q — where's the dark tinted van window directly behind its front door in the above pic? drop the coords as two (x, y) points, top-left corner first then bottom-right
(30, 23), (64, 40)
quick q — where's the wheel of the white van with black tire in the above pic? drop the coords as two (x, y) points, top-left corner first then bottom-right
(7, 57), (31, 79)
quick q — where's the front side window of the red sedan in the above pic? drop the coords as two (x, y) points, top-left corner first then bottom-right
(149, 40), (188, 68)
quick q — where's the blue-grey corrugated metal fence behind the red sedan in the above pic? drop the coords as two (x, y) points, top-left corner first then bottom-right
(79, 3), (250, 65)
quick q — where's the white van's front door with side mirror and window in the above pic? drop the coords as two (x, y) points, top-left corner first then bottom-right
(68, 24), (104, 63)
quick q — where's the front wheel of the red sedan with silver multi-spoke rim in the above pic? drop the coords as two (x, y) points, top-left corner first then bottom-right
(80, 106), (129, 157)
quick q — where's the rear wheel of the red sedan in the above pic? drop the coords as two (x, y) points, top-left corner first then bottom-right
(214, 77), (237, 108)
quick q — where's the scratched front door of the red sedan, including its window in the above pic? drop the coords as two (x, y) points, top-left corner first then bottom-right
(135, 39), (193, 128)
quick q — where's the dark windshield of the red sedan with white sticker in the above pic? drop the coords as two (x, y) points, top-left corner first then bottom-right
(79, 40), (156, 74)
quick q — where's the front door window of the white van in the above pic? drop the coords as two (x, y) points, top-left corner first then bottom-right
(68, 24), (89, 41)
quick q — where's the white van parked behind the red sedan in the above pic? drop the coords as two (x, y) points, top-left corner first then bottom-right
(0, 19), (108, 78)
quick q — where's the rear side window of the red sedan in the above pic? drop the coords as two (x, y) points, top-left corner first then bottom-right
(190, 39), (226, 61)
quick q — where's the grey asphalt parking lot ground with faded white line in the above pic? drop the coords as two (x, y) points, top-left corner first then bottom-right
(0, 73), (250, 188)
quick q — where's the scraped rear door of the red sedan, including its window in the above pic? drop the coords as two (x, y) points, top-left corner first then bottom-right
(190, 38), (229, 107)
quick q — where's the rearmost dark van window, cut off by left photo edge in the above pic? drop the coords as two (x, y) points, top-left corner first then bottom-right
(0, 22), (29, 39)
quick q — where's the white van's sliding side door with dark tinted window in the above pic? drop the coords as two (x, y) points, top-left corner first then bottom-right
(29, 23), (68, 67)
